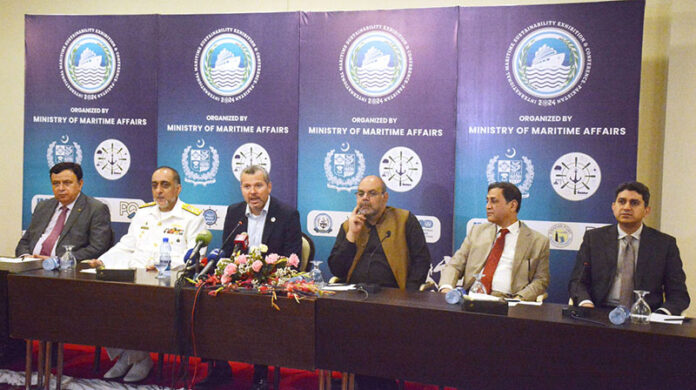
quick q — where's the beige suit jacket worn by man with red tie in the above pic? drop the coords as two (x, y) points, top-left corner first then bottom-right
(440, 221), (550, 300)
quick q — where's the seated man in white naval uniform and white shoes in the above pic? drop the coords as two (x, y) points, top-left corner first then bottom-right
(89, 167), (205, 382)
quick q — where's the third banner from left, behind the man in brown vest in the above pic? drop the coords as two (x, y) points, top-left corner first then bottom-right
(298, 8), (457, 269)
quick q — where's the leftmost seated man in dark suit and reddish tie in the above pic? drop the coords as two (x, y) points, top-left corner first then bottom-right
(15, 162), (112, 261)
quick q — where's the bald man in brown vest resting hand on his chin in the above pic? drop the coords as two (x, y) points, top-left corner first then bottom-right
(329, 176), (430, 290)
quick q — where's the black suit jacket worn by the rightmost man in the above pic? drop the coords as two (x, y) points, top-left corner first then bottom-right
(568, 225), (691, 314)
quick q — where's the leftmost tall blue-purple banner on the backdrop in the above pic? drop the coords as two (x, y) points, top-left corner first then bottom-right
(22, 15), (157, 235)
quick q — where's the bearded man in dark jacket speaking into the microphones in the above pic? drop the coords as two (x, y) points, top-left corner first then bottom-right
(197, 165), (302, 389)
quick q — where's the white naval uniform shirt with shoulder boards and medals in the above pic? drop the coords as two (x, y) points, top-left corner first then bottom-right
(99, 199), (205, 269)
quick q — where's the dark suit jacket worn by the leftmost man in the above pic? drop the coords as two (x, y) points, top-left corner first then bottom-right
(15, 193), (113, 261)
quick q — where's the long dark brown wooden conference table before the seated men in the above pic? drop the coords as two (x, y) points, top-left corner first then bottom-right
(8, 270), (696, 389)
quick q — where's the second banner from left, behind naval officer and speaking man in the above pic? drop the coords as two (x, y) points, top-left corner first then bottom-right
(157, 13), (299, 246)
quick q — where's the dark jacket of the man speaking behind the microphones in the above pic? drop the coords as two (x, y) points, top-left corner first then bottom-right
(222, 196), (302, 257)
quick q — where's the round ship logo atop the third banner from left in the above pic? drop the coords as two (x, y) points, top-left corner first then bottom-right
(338, 25), (413, 104)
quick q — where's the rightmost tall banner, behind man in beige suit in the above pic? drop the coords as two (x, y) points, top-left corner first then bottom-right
(455, 1), (644, 302)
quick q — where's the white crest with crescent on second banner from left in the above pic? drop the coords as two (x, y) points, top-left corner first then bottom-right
(181, 139), (220, 186)
